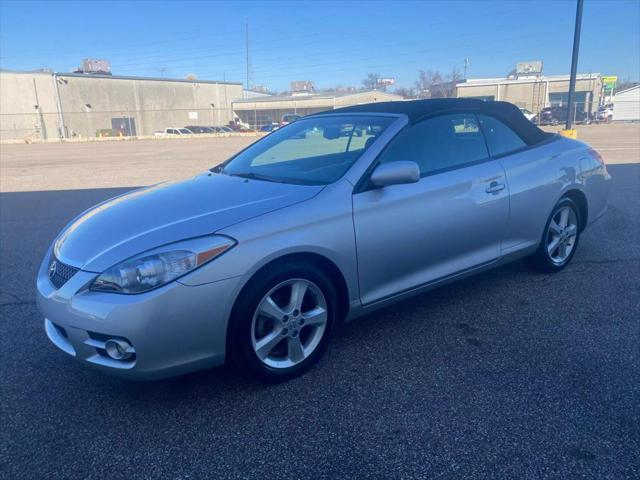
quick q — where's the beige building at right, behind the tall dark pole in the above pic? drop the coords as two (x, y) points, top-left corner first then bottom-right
(456, 73), (602, 117)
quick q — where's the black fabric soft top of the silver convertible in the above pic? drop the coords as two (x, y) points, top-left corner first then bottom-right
(322, 98), (554, 145)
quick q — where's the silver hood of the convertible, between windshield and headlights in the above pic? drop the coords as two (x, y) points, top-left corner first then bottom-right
(54, 173), (322, 272)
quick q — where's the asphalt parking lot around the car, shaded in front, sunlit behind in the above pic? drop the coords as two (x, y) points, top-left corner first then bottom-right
(0, 125), (640, 479)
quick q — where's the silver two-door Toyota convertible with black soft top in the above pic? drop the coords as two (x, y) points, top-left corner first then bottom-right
(37, 99), (610, 382)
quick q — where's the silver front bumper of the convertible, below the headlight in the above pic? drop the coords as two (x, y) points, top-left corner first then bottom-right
(36, 251), (239, 380)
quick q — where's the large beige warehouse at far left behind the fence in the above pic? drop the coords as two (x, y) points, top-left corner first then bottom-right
(0, 71), (243, 141)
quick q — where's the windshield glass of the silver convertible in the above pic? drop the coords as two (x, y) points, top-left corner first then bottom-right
(220, 115), (395, 185)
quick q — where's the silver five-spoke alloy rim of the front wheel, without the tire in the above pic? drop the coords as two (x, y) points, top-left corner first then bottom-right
(251, 278), (328, 369)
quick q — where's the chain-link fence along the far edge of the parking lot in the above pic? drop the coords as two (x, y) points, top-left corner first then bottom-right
(0, 100), (640, 143)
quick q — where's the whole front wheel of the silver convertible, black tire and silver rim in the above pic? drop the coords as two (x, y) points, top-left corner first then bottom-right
(228, 261), (337, 383)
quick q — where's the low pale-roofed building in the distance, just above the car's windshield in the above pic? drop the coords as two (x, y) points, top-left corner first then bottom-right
(233, 90), (404, 127)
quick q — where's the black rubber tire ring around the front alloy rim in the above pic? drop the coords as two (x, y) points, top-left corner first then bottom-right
(227, 262), (337, 383)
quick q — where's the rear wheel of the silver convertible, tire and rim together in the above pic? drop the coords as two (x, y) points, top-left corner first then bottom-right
(525, 197), (582, 273)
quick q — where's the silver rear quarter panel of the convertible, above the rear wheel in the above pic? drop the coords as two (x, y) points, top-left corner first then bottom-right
(501, 137), (608, 255)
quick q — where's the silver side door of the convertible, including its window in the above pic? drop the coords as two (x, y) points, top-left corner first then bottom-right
(353, 113), (509, 304)
